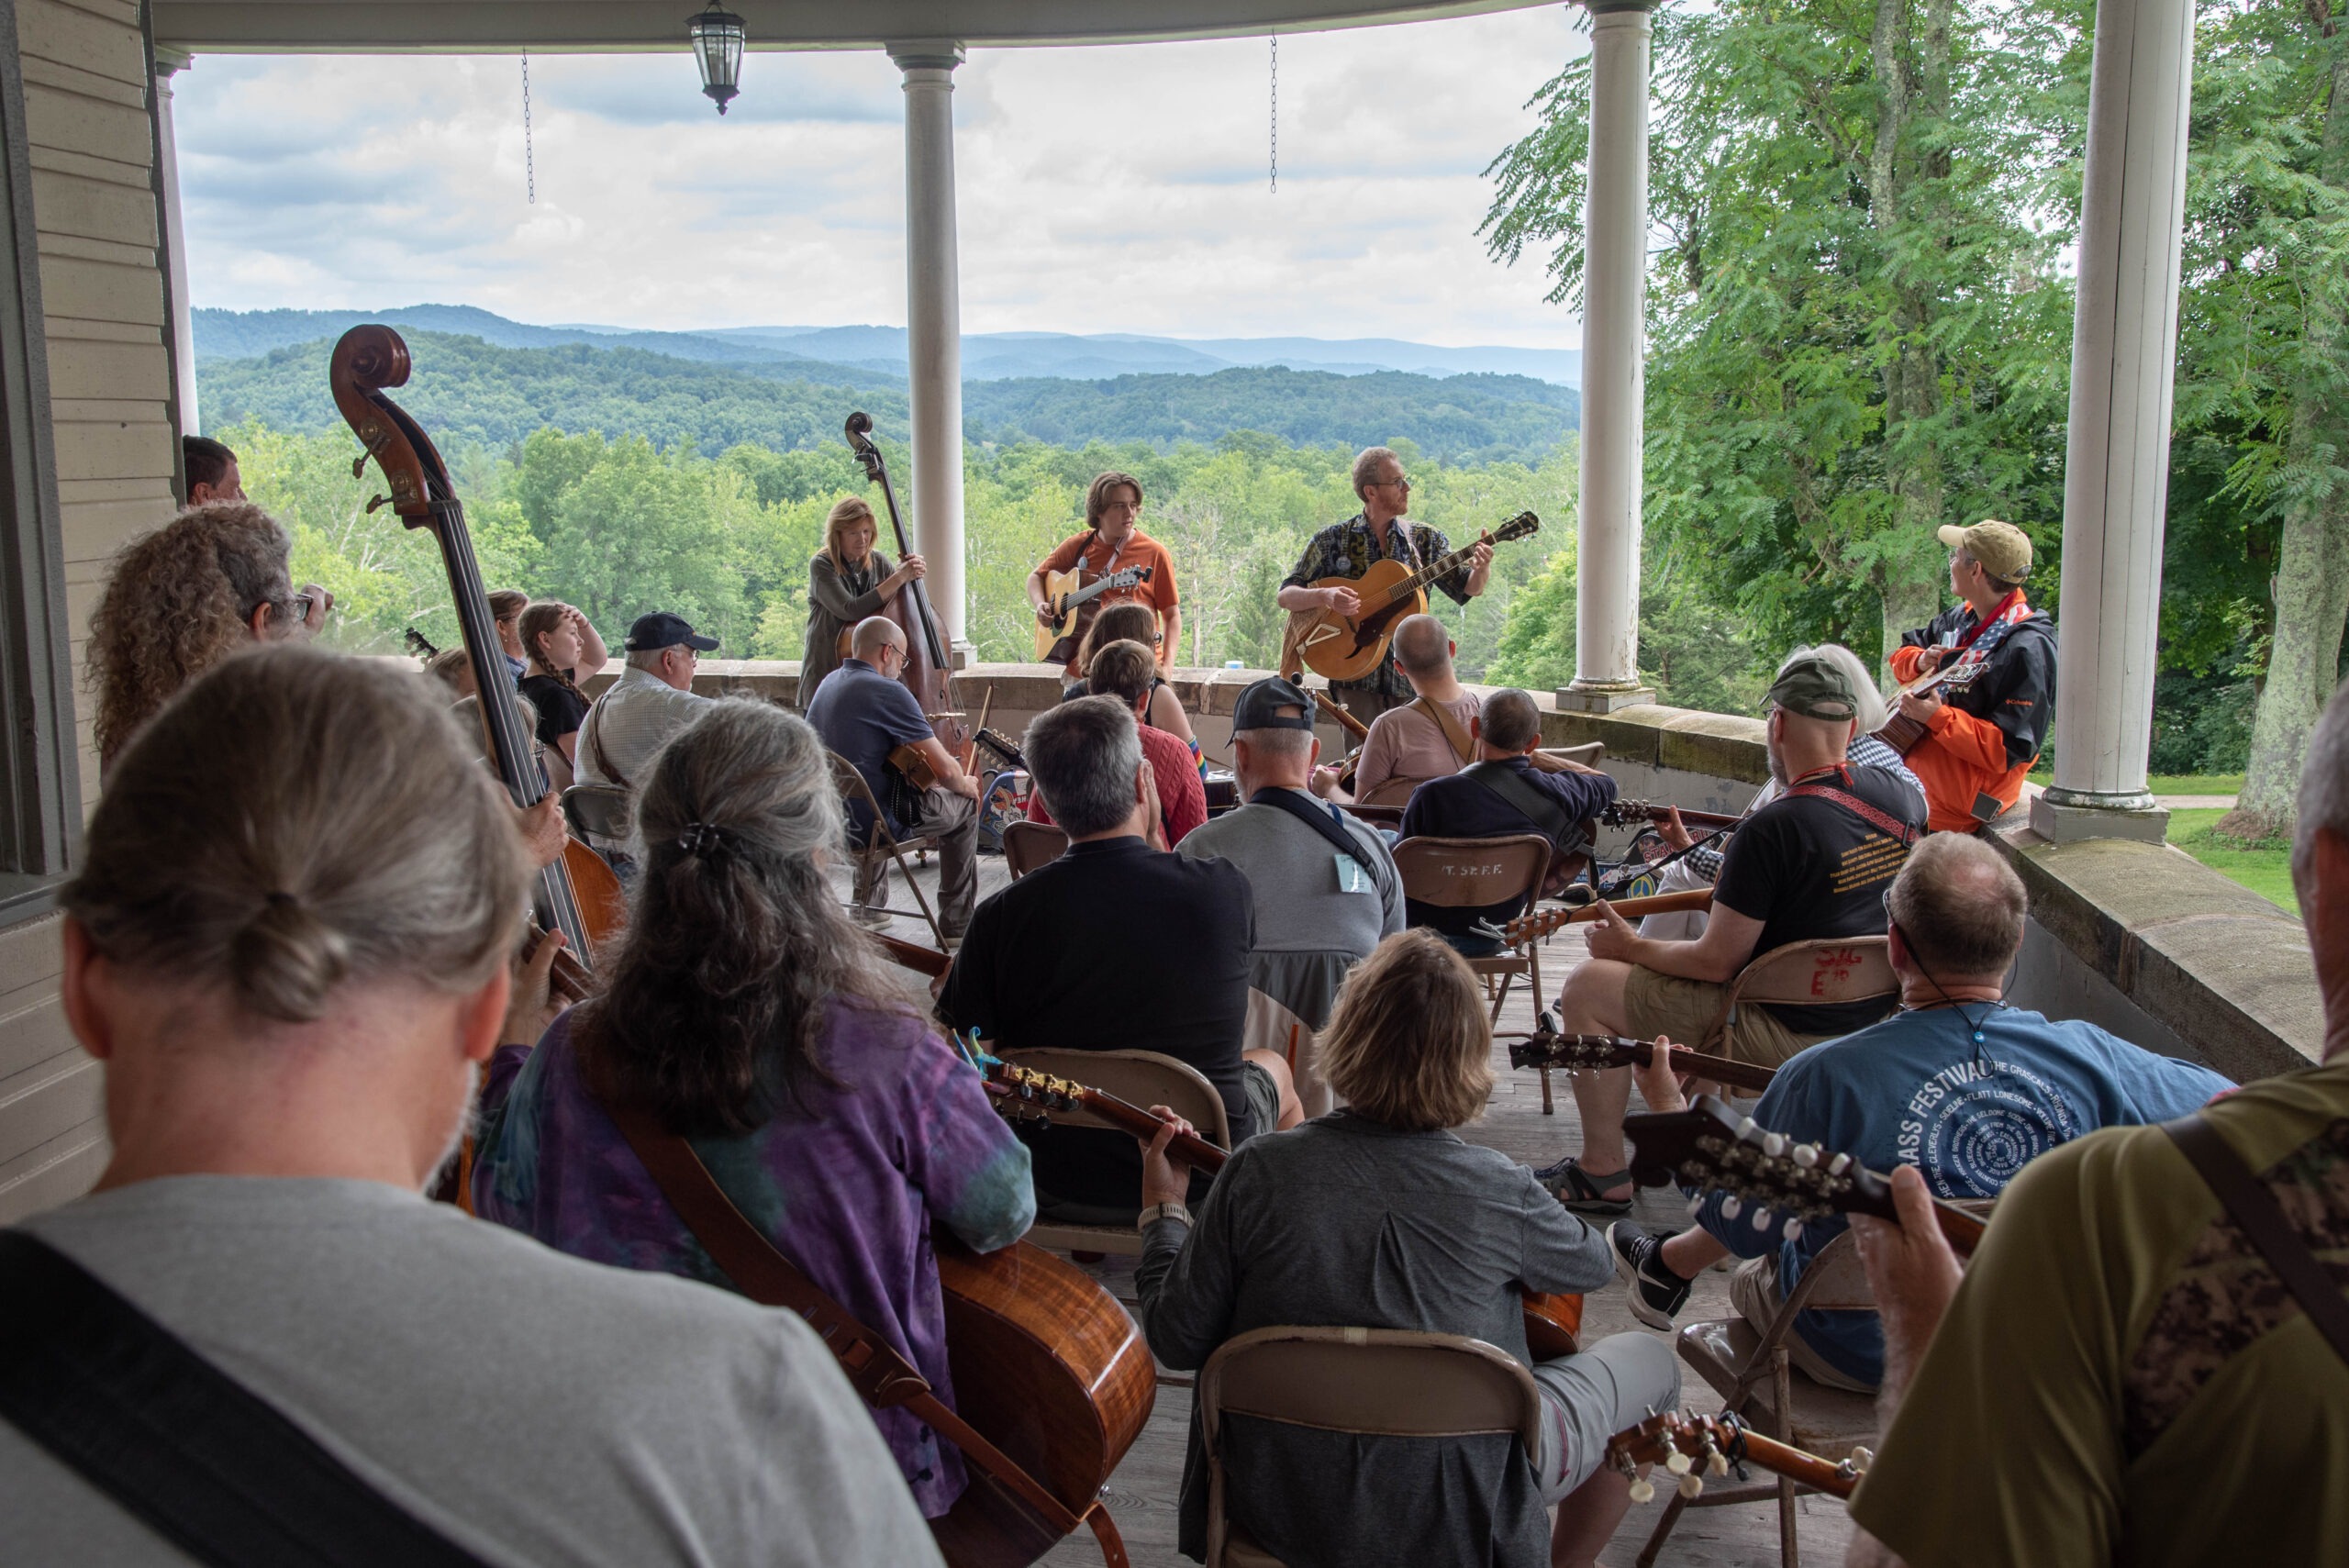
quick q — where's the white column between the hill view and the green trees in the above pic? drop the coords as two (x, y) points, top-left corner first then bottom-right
(1557, 0), (1656, 714)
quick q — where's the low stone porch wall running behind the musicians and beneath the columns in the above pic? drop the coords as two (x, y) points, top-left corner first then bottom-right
(634, 660), (2323, 1080)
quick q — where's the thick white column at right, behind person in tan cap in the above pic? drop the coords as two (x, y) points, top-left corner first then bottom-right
(2032, 0), (2194, 840)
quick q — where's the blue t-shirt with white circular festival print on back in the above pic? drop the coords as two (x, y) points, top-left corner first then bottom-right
(1698, 1002), (2234, 1383)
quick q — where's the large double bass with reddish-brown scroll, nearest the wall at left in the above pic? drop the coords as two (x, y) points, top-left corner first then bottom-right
(328, 327), (620, 972)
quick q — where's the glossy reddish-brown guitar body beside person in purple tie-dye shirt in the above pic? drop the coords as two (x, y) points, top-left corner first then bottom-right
(930, 1241), (1158, 1568)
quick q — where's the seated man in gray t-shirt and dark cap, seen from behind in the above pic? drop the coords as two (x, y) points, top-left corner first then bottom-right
(1174, 676), (1402, 1029)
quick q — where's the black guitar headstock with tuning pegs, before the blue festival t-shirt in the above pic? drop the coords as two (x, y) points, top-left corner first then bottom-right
(1623, 1094), (1896, 1241)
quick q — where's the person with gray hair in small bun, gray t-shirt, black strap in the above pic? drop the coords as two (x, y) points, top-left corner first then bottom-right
(0, 648), (940, 1568)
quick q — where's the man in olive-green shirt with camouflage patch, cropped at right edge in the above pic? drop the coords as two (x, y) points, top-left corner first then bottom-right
(1851, 690), (2349, 1568)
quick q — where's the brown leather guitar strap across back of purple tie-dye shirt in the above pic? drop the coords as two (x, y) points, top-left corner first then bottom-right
(596, 1094), (1128, 1568)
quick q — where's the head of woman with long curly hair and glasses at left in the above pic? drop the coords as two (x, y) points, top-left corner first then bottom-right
(89, 500), (334, 770)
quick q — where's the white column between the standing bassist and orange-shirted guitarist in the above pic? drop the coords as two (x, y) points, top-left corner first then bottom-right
(888, 39), (970, 651)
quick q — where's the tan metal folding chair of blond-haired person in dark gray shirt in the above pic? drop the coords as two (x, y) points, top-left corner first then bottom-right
(1196, 1329), (1541, 1568)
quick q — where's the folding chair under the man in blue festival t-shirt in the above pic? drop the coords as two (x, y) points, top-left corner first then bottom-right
(1640, 1239), (1879, 1568)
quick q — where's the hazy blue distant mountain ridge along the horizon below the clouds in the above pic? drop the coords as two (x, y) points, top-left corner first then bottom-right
(195, 306), (1583, 387)
